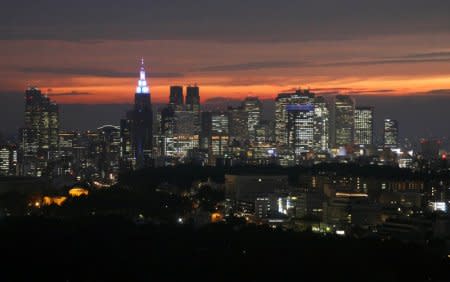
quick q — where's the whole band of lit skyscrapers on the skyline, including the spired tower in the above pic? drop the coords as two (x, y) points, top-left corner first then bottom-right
(0, 60), (446, 180)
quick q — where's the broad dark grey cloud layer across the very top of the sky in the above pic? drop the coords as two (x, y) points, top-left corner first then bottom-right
(0, 0), (450, 42)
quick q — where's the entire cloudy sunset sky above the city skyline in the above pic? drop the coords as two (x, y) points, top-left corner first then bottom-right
(0, 0), (450, 104)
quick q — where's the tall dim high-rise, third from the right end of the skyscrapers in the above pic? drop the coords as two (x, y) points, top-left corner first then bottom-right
(334, 95), (355, 147)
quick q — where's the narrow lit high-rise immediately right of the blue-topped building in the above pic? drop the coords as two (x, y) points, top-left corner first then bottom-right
(313, 96), (330, 152)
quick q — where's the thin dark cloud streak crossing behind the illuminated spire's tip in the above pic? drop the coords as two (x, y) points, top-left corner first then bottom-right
(18, 67), (183, 78)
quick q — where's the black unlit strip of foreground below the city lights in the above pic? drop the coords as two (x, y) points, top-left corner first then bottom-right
(0, 217), (450, 281)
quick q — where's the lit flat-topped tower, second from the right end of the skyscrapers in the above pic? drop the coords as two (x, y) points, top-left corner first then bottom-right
(354, 107), (373, 146)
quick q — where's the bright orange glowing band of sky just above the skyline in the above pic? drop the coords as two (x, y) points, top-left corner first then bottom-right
(26, 76), (450, 104)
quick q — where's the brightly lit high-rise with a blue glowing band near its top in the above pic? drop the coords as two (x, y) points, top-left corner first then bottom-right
(286, 103), (314, 156)
